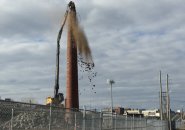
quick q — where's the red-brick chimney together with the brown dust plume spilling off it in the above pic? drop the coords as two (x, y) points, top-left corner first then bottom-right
(65, 1), (94, 109)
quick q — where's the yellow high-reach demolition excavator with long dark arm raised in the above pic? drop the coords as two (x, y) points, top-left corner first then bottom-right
(46, 2), (73, 106)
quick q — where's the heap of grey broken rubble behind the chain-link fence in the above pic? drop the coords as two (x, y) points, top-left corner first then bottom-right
(0, 111), (65, 130)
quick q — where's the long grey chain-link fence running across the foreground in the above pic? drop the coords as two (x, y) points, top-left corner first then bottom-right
(0, 101), (171, 130)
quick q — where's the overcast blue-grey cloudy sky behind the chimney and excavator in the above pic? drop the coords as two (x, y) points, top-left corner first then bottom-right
(0, 0), (185, 109)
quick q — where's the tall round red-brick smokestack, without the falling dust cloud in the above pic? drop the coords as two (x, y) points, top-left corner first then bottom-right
(65, 1), (79, 109)
